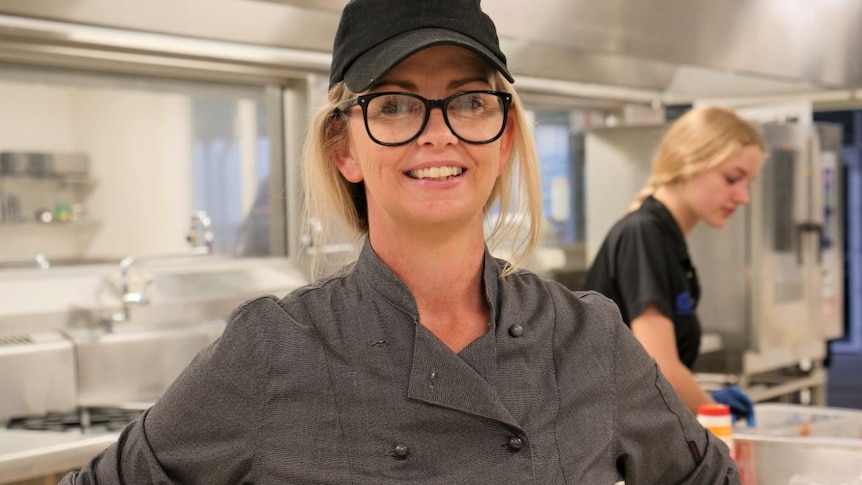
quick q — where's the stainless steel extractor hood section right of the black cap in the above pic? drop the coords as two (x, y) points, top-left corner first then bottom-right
(253, 0), (862, 101)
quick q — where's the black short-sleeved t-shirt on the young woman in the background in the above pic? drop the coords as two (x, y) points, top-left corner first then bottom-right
(584, 197), (701, 369)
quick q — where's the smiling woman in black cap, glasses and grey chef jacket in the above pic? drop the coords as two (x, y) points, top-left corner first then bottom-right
(63, 0), (739, 485)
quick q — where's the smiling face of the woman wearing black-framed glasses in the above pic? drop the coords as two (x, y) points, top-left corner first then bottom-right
(336, 46), (514, 240)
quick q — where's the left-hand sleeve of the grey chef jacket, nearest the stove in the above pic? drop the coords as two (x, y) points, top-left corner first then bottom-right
(60, 298), (277, 485)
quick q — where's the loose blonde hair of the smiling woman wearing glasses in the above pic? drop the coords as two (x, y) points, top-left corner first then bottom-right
(303, 72), (542, 276)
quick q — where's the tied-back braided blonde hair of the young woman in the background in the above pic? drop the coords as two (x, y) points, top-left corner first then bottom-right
(628, 106), (765, 212)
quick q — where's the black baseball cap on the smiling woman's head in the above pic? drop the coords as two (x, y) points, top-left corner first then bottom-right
(329, 0), (515, 93)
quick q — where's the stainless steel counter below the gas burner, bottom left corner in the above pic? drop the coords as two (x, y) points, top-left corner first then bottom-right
(0, 429), (119, 484)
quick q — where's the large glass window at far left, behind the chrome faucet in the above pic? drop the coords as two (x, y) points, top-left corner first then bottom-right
(0, 67), (286, 259)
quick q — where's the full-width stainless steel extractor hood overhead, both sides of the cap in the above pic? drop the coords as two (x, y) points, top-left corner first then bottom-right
(0, 0), (862, 103)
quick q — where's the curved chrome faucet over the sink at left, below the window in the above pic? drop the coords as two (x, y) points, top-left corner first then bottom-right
(105, 211), (213, 329)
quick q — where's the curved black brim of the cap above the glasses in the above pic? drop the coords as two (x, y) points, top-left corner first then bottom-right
(344, 28), (515, 93)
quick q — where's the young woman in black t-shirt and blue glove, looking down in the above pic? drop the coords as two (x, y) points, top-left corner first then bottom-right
(584, 106), (764, 422)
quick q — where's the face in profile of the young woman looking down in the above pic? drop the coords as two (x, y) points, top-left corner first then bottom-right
(682, 145), (763, 228)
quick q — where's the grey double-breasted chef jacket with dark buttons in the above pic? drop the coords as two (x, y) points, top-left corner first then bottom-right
(61, 240), (739, 485)
